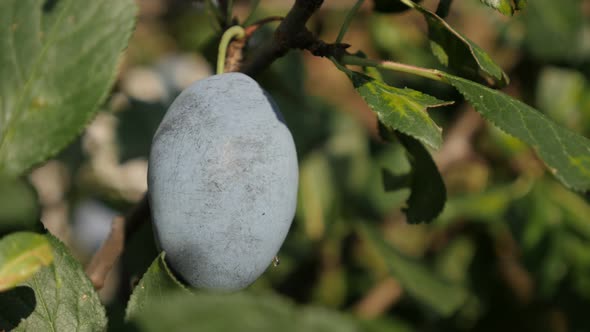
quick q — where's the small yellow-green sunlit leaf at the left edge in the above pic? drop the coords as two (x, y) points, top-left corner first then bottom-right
(0, 232), (53, 292)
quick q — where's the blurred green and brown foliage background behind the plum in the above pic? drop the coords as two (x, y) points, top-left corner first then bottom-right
(0, 0), (590, 332)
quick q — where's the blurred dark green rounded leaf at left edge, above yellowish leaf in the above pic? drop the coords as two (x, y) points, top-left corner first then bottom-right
(0, 177), (41, 235)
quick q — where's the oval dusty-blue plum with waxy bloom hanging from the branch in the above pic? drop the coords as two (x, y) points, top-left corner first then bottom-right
(148, 73), (298, 291)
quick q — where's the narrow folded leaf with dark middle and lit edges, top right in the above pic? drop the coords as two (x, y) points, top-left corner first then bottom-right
(403, 0), (509, 87)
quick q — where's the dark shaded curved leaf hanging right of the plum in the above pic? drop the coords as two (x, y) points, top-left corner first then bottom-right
(397, 134), (447, 224)
